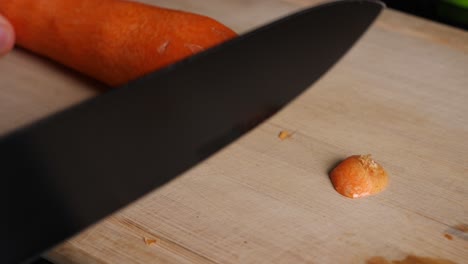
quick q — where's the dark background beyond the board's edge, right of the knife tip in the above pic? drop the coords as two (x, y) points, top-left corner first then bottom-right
(382, 0), (468, 30)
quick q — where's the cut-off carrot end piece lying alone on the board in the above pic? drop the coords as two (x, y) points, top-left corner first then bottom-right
(330, 155), (388, 198)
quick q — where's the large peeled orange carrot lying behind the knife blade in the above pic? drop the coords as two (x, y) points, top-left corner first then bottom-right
(0, 0), (236, 86)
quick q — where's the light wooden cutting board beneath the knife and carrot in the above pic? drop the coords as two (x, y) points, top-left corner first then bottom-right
(0, 0), (468, 263)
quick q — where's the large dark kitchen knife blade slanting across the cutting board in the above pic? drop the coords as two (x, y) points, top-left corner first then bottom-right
(0, 0), (383, 263)
